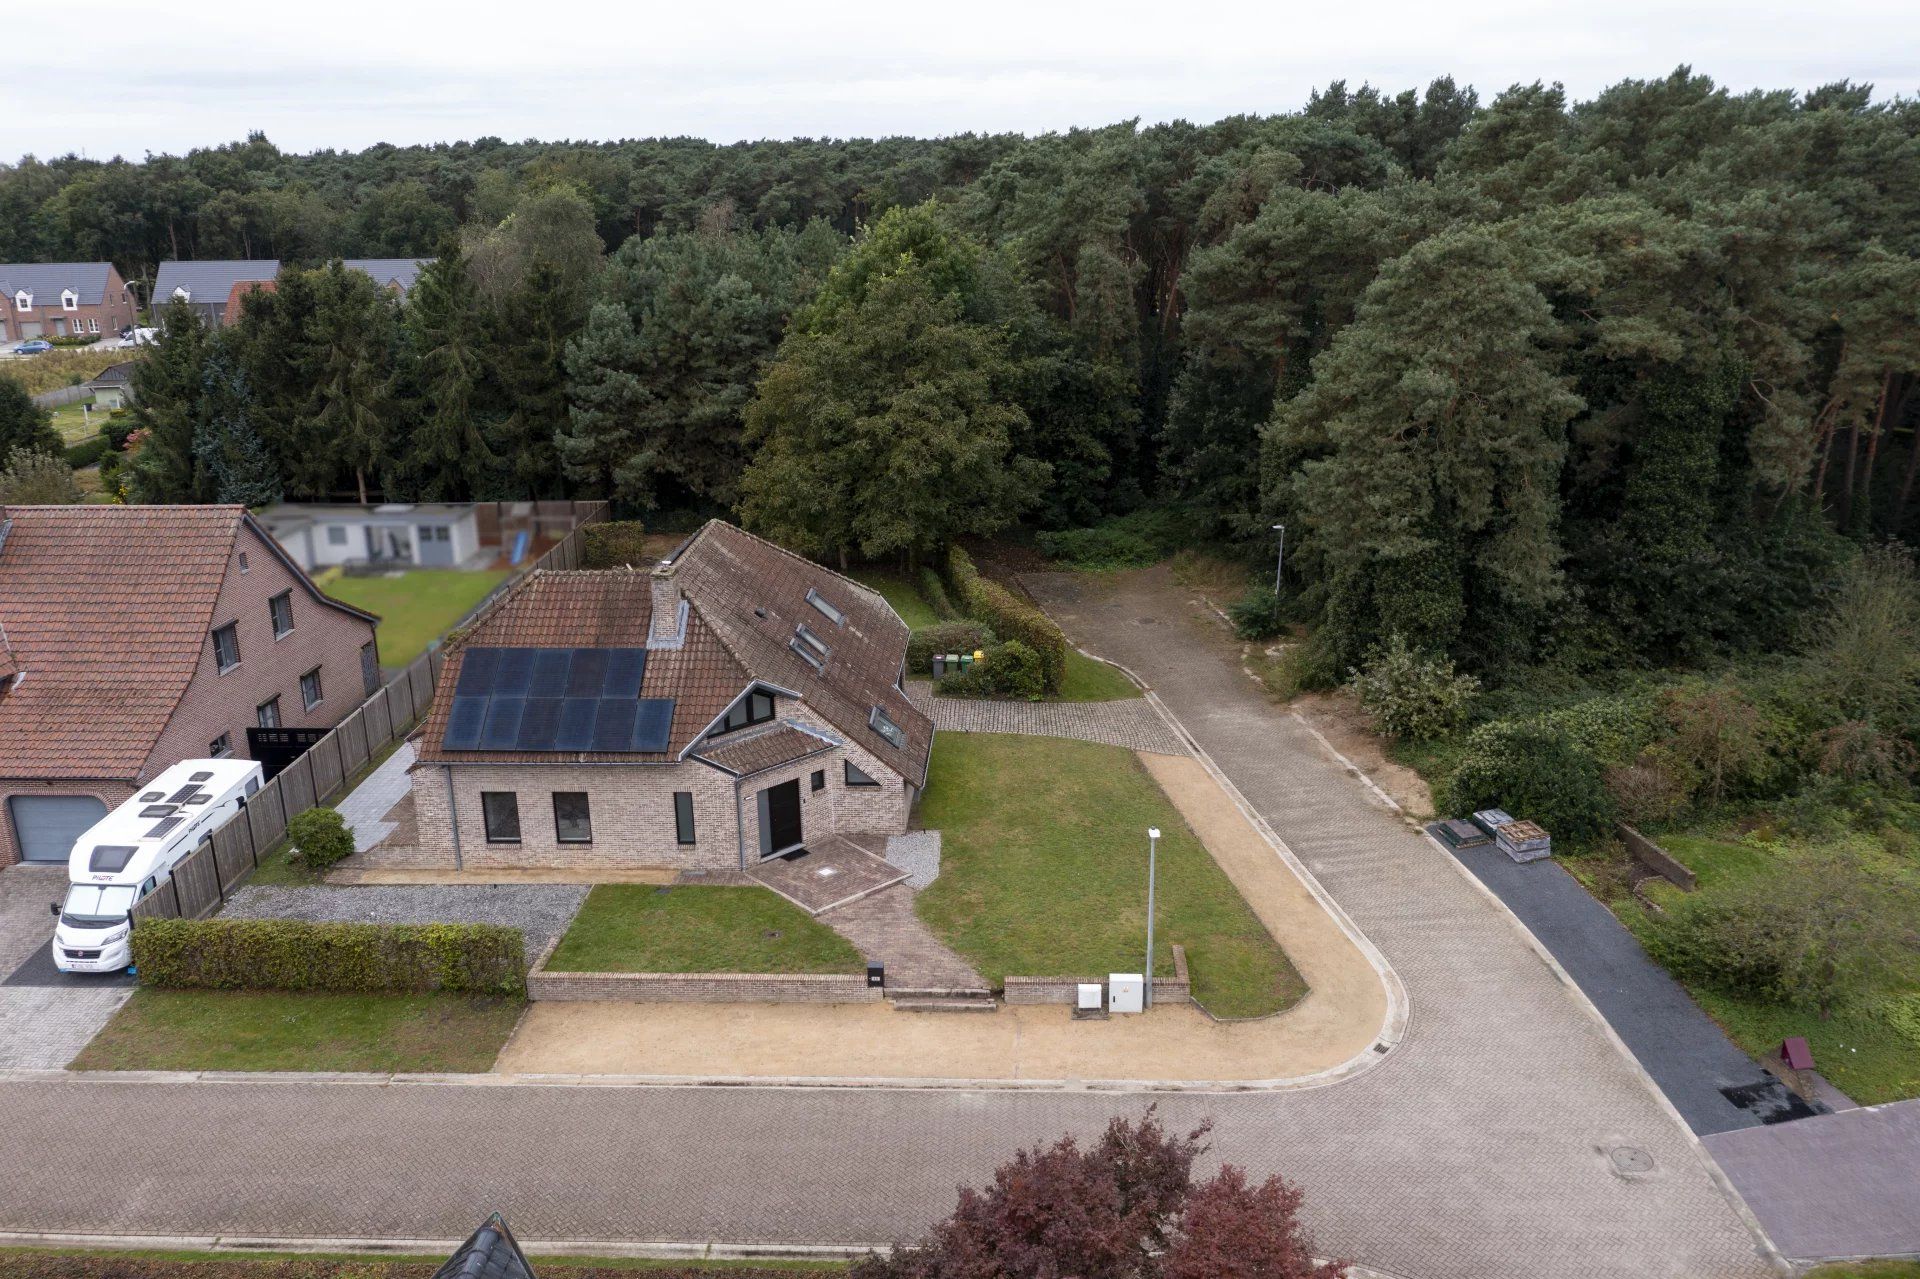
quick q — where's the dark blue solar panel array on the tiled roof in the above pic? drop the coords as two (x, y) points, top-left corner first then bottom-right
(442, 649), (674, 753)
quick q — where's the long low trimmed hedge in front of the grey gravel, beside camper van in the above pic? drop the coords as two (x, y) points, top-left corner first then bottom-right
(132, 920), (526, 995)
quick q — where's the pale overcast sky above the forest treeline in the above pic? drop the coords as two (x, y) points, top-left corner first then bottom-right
(0, 0), (1920, 159)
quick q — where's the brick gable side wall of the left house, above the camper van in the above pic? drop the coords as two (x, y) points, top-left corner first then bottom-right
(140, 522), (374, 780)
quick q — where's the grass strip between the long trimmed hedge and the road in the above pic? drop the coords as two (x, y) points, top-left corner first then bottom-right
(73, 989), (524, 1074)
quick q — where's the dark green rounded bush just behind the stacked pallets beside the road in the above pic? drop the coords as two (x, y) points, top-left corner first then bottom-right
(1434, 722), (1615, 851)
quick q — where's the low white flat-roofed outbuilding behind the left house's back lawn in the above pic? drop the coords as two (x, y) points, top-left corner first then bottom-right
(259, 501), (480, 572)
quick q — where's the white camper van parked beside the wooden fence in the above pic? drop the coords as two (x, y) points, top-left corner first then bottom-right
(54, 759), (261, 972)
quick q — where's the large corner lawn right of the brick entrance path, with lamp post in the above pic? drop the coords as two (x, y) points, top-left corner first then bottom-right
(916, 734), (1306, 1018)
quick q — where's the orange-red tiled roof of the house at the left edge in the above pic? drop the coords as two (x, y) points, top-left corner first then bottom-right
(0, 505), (371, 778)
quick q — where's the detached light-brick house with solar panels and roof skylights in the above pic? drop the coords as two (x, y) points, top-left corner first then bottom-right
(413, 520), (933, 870)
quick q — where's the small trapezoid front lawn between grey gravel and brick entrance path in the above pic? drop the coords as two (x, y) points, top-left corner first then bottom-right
(547, 883), (864, 972)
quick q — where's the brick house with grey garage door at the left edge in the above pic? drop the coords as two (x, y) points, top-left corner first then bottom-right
(0, 505), (380, 864)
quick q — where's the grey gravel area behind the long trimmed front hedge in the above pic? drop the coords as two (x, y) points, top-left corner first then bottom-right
(221, 883), (588, 962)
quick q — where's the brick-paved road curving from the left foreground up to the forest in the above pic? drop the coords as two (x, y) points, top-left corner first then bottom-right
(0, 574), (1770, 1279)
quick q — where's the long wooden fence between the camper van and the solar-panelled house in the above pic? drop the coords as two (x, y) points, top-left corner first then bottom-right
(132, 503), (607, 926)
